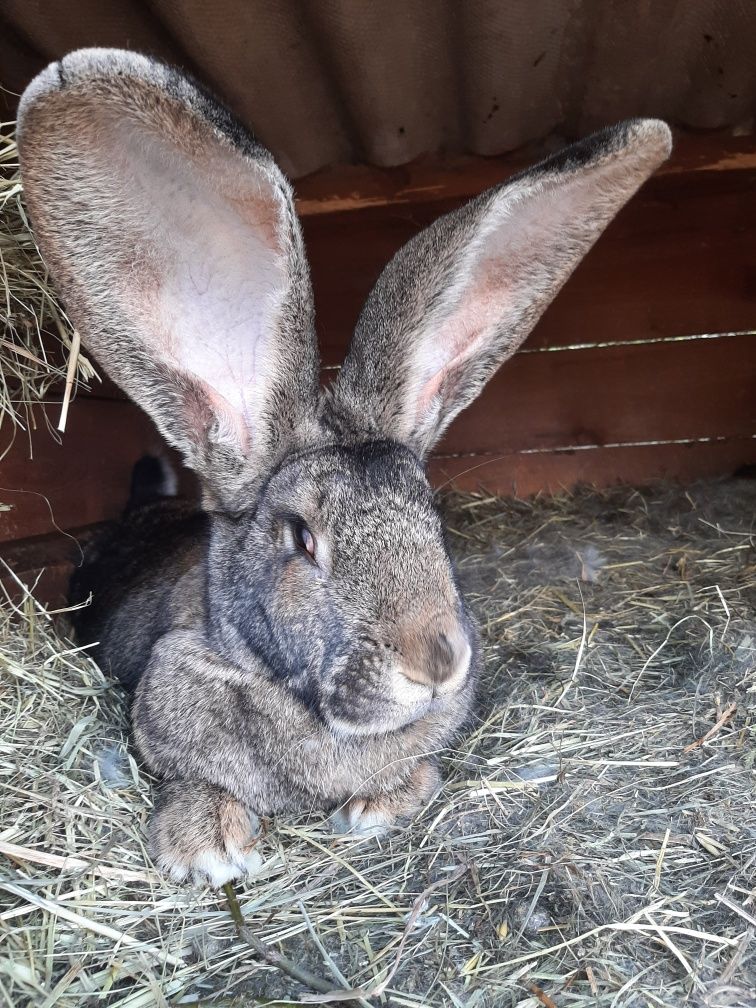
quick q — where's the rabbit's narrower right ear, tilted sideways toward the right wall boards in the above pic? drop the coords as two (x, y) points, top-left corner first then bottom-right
(330, 119), (670, 456)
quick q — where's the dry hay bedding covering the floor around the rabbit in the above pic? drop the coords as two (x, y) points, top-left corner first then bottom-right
(0, 473), (756, 1008)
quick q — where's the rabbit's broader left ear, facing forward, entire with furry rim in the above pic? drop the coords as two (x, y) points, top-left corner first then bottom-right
(18, 49), (319, 507)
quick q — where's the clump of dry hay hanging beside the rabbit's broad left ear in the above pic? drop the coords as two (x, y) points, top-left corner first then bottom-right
(0, 123), (95, 458)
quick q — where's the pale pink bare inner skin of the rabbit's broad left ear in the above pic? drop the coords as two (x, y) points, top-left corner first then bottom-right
(99, 112), (287, 445)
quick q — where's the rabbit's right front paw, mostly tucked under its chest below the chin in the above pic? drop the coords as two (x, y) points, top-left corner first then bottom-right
(331, 760), (440, 837)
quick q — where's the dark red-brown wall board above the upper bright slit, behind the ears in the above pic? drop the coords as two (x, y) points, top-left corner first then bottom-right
(303, 170), (756, 365)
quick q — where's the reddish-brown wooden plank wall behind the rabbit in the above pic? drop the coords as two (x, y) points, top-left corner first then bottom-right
(0, 135), (756, 596)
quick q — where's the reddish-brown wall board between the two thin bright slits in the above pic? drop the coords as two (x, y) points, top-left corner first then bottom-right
(439, 335), (756, 453)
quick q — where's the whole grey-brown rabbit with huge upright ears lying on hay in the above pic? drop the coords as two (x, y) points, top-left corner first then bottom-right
(19, 49), (669, 884)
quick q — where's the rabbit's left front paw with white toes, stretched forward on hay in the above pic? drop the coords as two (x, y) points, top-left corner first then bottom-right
(150, 781), (262, 888)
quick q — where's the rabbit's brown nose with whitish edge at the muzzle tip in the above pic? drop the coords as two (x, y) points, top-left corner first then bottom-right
(399, 624), (471, 692)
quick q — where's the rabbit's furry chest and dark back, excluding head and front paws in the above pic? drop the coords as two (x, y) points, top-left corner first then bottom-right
(73, 502), (473, 813)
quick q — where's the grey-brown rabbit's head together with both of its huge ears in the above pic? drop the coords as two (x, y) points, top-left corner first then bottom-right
(19, 49), (670, 734)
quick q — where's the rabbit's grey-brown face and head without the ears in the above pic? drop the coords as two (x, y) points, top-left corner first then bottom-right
(209, 440), (476, 734)
